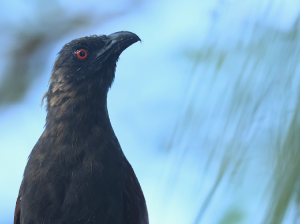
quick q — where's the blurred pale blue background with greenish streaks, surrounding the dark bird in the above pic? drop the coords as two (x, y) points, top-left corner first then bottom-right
(0, 0), (300, 224)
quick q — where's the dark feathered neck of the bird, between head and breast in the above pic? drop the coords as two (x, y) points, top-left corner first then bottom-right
(43, 86), (116, 143)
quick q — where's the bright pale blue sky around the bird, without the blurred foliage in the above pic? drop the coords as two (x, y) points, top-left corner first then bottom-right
(0, 0), (300, 224)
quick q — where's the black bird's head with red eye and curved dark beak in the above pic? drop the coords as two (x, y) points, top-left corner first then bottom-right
(45, 31), (140, 109)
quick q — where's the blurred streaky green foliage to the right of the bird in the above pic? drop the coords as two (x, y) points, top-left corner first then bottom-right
(177, 13), (300, 224)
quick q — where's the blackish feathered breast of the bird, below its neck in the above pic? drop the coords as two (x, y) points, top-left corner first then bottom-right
(21, 132), (126, 223)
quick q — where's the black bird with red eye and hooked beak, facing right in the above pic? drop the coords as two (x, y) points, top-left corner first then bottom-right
(14, 31), (149, 224)
